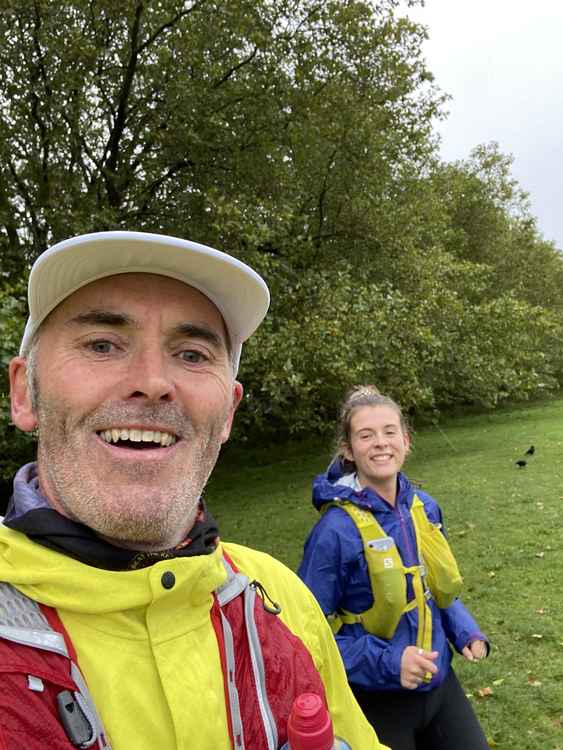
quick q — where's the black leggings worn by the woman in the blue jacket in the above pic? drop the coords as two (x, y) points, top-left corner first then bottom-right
(351, 669), (489, 750)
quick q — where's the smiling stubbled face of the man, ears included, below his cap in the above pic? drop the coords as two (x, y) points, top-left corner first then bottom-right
(11, 274), (242, 549)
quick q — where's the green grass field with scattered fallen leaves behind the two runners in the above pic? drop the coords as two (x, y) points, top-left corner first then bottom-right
(206, 400), (563, 750)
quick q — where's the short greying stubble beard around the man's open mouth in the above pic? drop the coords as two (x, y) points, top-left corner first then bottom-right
(35, 393), (228, 551)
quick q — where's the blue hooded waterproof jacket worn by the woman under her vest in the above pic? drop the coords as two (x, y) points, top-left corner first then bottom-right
(298, 463), (486, 691)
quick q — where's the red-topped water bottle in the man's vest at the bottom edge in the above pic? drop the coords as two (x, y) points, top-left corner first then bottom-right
(281, 693), (352, 750)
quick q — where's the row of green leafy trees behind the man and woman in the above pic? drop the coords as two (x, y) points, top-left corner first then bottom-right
(0, 0), (563, 477)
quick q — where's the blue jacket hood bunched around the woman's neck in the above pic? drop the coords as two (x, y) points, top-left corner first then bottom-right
(313, 459), (413, 511)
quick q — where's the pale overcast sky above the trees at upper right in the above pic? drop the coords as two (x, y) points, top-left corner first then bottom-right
(408, 0), (563, 250)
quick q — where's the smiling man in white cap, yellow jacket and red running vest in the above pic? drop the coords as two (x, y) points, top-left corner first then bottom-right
(0, 232), (388, 750)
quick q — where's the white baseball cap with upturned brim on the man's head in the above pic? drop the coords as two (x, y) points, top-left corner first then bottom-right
(20, 231), (270, 372)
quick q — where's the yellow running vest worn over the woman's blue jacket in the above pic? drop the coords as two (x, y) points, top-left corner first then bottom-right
(323, 495), (462, 677)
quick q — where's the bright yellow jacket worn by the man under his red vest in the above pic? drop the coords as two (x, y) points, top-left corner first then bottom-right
(0, 526), (384, 750)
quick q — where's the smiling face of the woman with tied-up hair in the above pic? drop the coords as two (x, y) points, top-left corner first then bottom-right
(344, 405), (410, 488)
